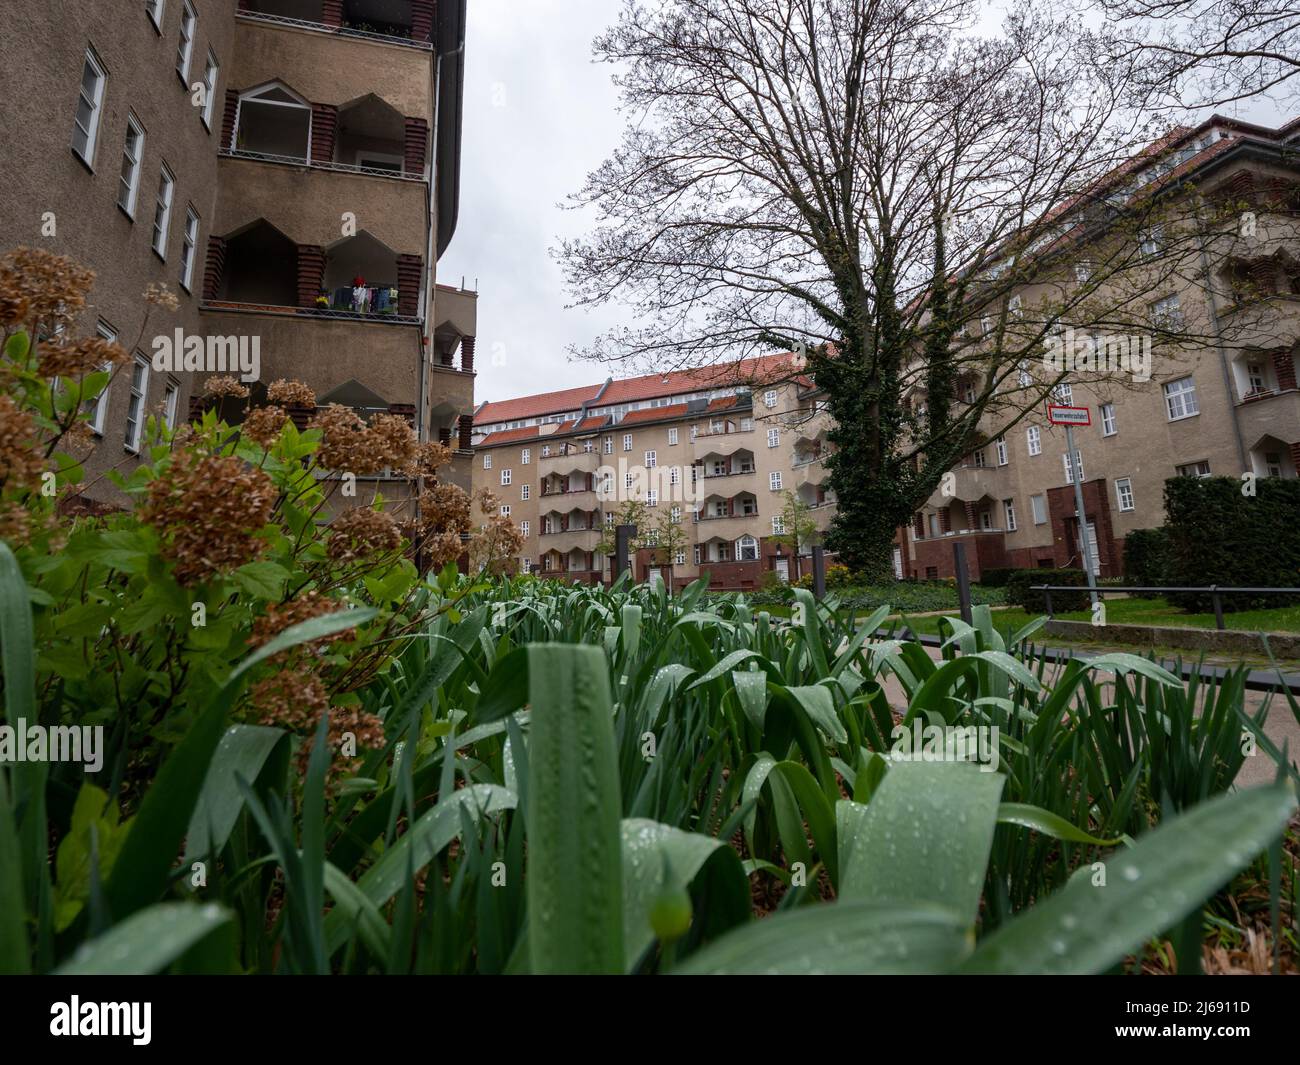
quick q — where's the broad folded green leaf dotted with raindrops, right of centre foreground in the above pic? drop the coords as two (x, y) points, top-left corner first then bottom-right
(840, 762), (1006, 926)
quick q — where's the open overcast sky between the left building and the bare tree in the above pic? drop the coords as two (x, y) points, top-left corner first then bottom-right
(438, 0), (1279, 402)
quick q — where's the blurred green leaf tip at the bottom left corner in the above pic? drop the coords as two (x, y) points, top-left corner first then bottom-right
(55, 902), (234, 977)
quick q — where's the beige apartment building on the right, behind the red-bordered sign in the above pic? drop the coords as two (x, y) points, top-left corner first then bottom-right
(894, 117), (1300, 579)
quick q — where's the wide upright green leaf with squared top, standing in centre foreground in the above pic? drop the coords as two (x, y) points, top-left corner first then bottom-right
(527, 642), (628, 974)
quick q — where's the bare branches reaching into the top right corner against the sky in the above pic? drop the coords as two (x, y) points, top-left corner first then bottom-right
(1099, 0), (1300, 108)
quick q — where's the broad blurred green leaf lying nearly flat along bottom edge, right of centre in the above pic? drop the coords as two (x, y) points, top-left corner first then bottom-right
(675, 901), (970, 977)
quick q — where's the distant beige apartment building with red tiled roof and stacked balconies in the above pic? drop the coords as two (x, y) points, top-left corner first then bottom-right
(473, 355), (833, 589)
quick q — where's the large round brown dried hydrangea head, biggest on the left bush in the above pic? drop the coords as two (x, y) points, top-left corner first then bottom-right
(140, 455), (278, 585)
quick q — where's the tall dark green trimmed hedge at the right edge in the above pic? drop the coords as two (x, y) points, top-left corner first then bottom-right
(1165, 477), (1300, 611)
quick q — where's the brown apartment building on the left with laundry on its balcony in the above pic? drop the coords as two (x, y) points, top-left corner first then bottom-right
(0, 0), (477, 502)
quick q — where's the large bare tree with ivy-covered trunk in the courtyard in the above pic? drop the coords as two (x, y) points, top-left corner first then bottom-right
(559, 0), (1248, 577)
